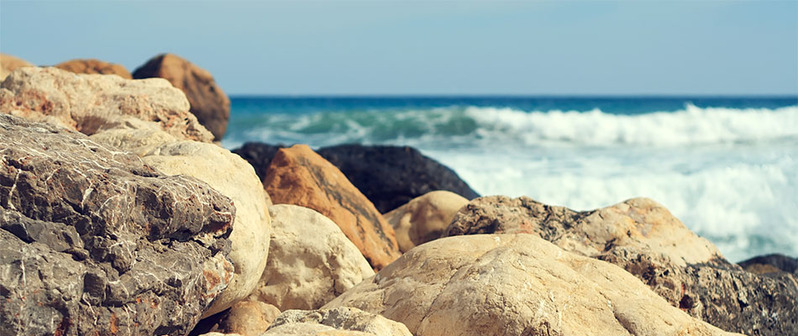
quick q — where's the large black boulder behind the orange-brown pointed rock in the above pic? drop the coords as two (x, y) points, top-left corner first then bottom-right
(319, 145), (479, 213)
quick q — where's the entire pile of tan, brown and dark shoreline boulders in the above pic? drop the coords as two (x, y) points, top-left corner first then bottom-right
(0, 55), (798, 336)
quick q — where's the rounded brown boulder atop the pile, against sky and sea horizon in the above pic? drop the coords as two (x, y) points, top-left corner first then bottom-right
(133, 54), (230, 140)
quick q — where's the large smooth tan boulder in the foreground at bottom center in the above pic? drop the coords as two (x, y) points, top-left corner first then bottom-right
(324, 234), (727, 336)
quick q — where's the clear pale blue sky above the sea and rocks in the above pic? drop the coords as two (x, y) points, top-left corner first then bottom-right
(0, 0), (798, 95)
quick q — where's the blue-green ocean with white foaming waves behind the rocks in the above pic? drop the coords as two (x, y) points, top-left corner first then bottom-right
(222, 97), (798, 262)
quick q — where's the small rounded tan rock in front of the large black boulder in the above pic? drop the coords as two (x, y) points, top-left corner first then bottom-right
(383, 190), (468, 253)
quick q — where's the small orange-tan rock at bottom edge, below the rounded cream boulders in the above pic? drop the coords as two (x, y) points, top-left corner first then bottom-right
(220, 300), (280, 336)
